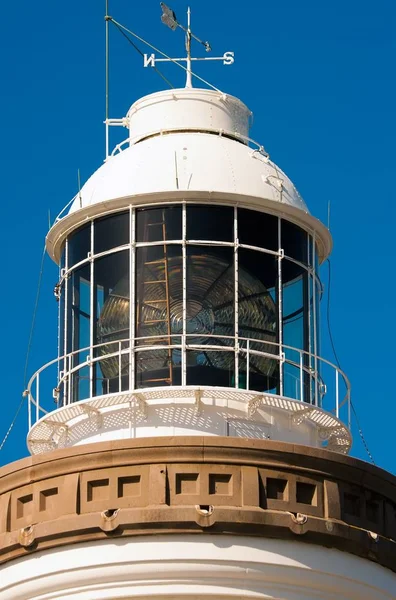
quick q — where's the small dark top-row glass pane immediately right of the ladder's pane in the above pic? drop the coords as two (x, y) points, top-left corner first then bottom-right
(187, 204), (234, 242)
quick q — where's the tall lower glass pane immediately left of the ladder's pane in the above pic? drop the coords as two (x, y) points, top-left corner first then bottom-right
(94, 250), (130, 394)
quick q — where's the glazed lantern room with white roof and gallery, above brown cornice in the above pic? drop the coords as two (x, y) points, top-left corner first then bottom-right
(28, 88), (350, 452)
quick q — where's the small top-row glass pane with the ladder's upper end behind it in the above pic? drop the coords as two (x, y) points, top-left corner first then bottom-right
(136, 205), (182, 242)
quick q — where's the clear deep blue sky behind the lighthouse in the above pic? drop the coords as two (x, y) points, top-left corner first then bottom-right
(0, 0), (396, 472)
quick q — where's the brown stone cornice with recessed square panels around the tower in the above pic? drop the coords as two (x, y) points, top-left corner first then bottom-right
(0, 436), (396, 571)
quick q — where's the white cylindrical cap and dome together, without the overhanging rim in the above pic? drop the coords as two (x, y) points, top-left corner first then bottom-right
(65, 88), (308, 213)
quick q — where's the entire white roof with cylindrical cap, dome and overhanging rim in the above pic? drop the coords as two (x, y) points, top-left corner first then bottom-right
(47, 88), (331, 261)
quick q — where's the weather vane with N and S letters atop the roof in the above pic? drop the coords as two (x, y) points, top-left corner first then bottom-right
(143, 2), (234, 88)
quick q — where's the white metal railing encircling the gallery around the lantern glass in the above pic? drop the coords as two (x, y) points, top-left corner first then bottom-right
(27, 332), (351, 429)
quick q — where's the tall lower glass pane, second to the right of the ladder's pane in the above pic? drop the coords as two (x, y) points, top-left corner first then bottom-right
(238, 248), (279, 391)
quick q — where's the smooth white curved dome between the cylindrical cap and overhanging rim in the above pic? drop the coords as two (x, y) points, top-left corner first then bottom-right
(70, 132), (308, 213)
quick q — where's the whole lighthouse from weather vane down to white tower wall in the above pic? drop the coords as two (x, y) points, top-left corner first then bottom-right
(0, 7), (396, 600)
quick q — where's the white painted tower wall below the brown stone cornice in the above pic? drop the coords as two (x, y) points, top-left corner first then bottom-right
(0, 535), (396, 600)
